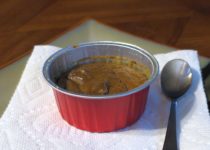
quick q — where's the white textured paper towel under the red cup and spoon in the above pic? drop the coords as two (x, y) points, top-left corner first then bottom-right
(0, 46), (210, 150)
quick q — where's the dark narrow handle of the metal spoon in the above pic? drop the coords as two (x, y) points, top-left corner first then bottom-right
(163, 101), (178, 150)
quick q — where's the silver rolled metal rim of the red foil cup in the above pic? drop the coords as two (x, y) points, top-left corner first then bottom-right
(42, 41), (159, 100)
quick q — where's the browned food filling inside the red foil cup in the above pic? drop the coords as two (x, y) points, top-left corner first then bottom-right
(58, 57), (149, 95)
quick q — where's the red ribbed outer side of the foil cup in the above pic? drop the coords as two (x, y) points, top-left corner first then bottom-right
(54, 87), (149, 132)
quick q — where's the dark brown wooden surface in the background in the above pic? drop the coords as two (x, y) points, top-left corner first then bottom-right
(0, 0), (210, 68)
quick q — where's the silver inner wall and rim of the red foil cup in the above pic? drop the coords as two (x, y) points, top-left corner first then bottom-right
(43, 42), (159, 98)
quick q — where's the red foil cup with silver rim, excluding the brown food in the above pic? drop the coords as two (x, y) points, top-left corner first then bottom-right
(43, 41), (159, 132)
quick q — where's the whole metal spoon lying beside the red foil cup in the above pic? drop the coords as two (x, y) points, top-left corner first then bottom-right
(161, 59), (192, 150)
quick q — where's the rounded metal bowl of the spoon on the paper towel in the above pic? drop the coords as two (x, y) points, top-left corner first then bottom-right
(161, 59), (192, 100)
